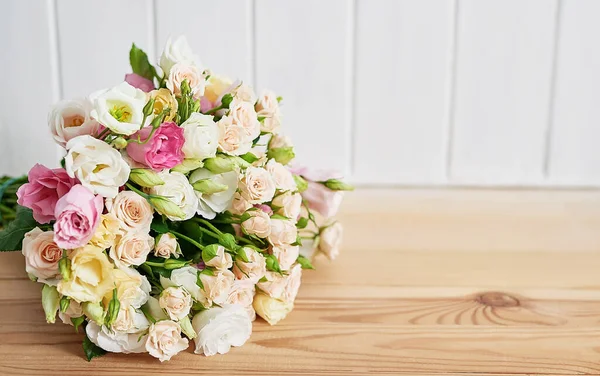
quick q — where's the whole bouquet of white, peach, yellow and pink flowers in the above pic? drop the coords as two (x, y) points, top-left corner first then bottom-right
(0, 37), (352, 361)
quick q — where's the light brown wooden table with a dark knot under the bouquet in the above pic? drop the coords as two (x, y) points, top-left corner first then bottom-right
(0, 190), (600, 375)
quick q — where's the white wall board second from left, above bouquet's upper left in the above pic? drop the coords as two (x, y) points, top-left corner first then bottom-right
(57, 0), (153, 98)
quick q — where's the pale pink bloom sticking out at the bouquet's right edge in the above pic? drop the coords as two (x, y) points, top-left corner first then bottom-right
(290, 167), (344, 218)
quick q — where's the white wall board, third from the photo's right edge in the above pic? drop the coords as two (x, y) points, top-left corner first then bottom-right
(354, 0), (454, 184)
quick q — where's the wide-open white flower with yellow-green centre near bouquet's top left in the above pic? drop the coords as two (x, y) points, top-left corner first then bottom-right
(90, 82), (153, 136)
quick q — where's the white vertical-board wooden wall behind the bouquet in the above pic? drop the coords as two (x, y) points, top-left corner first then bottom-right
(0, 0), (600, 187)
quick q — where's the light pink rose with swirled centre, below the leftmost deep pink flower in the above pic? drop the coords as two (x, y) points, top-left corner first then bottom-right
(54, 184), (103, 249)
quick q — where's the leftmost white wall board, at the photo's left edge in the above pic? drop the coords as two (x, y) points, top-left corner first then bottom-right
(0, 0), (58, 175)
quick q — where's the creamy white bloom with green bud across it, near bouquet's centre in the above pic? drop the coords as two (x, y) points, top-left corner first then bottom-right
(190, 168), (238, 219)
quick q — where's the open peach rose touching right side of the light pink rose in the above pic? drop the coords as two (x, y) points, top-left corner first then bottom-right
(105, 191), (153, 233)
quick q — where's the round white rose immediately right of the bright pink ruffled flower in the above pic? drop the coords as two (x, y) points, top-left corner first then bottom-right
(181, 112), (219, 161)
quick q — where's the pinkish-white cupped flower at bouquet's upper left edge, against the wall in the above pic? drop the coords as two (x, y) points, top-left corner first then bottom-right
(48, 98), (100, 148)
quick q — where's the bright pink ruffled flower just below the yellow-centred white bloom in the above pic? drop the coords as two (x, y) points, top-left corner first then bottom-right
(127, 122), (185, 171)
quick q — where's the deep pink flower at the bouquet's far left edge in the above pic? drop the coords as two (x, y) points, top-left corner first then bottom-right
(17, 164), (79, 223)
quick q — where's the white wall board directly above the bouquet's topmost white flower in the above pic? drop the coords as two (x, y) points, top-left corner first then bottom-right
(156, 0), (253, 83)
